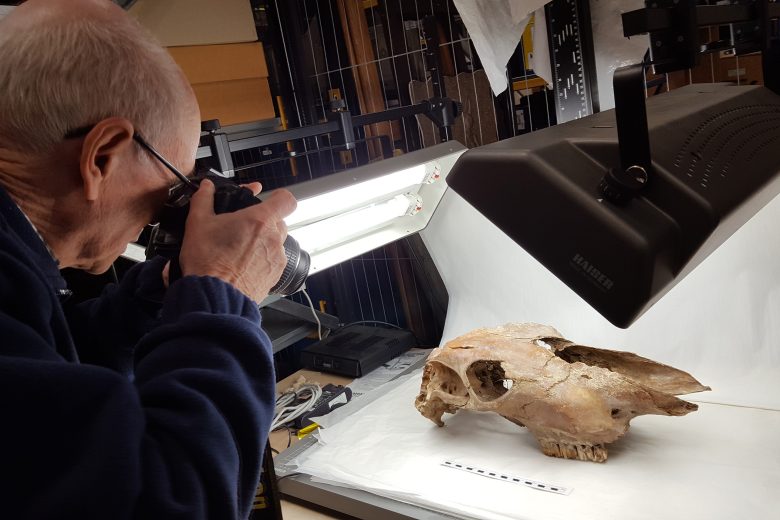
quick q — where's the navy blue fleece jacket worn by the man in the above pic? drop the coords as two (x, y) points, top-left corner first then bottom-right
(0, 185), (275, 520)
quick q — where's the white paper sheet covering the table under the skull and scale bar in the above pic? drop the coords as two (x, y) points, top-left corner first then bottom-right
(290, 377), (780, 520)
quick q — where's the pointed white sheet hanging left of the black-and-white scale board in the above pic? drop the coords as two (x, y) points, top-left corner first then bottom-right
(454, 0), (547, 95)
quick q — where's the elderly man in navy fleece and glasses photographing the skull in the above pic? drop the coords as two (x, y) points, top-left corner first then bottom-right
(0, 0), (295, 519)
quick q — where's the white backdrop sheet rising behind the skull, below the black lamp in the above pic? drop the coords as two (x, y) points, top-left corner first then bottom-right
(422, 190), (780, 410)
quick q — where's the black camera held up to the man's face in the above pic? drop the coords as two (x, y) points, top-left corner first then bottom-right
(146, 173), (311, 296)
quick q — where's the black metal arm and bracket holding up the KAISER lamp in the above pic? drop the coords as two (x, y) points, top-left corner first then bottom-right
(598, 0), (780, 205)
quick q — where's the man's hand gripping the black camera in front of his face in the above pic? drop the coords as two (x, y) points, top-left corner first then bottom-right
(179, 180), (296, 302)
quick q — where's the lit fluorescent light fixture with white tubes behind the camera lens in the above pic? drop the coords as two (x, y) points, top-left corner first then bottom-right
(272, 141), (466, 274)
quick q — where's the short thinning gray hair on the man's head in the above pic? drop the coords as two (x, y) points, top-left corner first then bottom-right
(0, 9), (185, 153)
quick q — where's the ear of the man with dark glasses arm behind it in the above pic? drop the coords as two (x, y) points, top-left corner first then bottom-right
(79, 117), (135, 201)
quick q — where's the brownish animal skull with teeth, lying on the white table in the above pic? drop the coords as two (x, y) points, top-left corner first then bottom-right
(415, 323), (710, 462)
